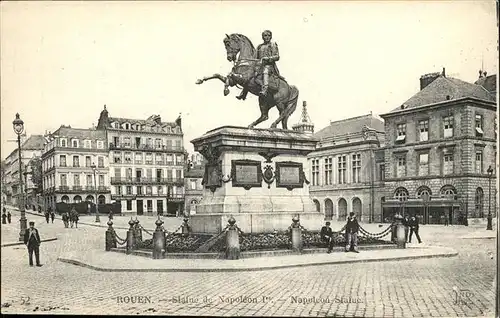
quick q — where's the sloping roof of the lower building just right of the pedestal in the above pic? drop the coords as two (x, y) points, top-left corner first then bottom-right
(314, 114), (384, 139)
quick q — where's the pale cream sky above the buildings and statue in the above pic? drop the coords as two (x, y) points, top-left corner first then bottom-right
(0, 1), (498, 158)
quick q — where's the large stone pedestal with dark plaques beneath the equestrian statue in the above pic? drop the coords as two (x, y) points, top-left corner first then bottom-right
(190, 126), (324, 233)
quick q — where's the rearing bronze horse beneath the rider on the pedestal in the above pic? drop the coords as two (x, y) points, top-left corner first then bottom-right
(196, 33), (299, 129)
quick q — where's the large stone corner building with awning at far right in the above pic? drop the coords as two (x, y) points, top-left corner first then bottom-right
(381, 69), (497, 224)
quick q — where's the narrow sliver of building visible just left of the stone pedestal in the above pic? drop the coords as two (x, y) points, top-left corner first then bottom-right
(184, 153), (205, 215)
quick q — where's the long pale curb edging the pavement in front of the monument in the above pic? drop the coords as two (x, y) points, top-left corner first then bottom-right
(57, 251), (458, 273)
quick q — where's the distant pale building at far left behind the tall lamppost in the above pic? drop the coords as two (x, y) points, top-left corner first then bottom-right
(4, 135), (45, 205)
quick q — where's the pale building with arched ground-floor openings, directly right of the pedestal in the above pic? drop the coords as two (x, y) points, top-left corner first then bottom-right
(308, 114), (384, 222)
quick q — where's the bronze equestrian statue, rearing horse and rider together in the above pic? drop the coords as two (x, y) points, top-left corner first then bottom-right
(196, 30), (299, 129)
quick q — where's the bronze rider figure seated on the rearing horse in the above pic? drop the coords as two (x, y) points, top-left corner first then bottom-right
(257, 30), (280, 96)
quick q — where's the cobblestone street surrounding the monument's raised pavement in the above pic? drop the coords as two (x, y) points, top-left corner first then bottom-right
(1, 207), (495, 317)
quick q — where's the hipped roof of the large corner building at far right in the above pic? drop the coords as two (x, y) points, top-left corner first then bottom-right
(391, 75), (495, 113)
